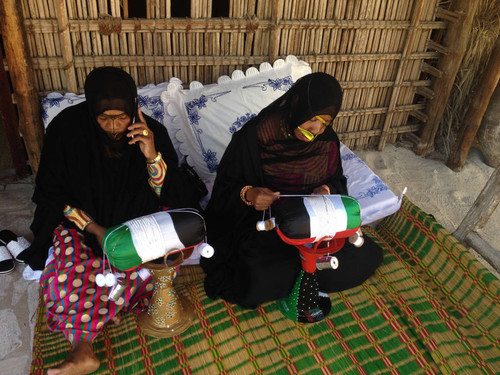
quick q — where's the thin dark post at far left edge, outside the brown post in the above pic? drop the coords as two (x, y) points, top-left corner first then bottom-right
(0, 48), (29, 177)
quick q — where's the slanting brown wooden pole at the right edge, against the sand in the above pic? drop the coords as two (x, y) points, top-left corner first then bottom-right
(446, 37), (500, 172)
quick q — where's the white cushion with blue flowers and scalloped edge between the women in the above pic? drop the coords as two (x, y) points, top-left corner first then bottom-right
(161, 56), (311, 182)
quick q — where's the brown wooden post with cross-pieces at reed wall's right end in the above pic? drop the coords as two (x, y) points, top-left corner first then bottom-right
(415, 0), (479, 155)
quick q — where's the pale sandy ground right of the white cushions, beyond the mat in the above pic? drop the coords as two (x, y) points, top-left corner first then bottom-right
(356, 145), (500, 250)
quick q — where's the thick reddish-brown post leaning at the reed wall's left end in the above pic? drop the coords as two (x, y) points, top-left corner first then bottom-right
(0, 0), (43, 174)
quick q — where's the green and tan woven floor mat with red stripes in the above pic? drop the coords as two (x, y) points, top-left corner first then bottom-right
(31, 198), (500, 375)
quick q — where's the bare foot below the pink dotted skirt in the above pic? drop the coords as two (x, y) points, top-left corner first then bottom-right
(47, 341), (100, 375)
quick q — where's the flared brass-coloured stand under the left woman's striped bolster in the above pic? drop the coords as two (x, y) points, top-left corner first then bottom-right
(137, 249), (194, 337)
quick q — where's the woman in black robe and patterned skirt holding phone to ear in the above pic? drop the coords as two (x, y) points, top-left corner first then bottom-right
(20, 67), (198, 374)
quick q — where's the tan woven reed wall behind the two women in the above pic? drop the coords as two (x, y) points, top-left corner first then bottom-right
(16, 0), (448, 149)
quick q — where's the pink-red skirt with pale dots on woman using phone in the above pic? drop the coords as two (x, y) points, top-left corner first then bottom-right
(40, 225), (154, 342)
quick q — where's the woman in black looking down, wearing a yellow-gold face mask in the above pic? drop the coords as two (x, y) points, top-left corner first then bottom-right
(201, 73), (382, 308)
